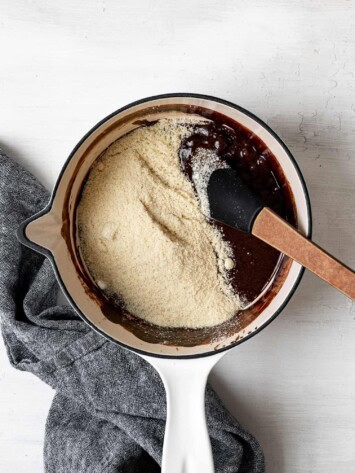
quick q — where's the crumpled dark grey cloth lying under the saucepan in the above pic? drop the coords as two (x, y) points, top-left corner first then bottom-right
(0, 152), (264, 473)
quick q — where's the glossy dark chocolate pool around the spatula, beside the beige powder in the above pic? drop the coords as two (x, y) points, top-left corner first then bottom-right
(180, 116), (295, 302)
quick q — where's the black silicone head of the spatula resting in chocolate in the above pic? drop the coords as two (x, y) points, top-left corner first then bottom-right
(207, 168), (264, 233)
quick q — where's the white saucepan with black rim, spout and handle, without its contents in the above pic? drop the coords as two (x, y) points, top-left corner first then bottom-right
(18, 94), (311, 473)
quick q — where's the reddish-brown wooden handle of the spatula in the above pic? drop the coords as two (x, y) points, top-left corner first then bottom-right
(252, 208), (355, 301)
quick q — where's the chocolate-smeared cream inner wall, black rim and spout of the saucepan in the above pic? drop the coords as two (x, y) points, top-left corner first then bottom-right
(19, 94), (311, 357)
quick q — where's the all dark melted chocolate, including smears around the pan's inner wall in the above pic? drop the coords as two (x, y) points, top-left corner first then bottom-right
(70, 105), (296, 351)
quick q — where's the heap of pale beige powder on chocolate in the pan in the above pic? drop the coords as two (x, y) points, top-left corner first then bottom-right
(77, 119), (241, 328)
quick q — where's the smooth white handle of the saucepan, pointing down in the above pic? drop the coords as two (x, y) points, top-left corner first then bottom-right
(144, 353), (223, 473)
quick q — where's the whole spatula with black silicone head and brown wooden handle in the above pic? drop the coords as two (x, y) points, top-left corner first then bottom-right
(207, 168), (355, 300)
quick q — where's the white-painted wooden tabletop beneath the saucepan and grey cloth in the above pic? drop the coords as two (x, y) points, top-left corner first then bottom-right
(0, 0), (355, 473)
